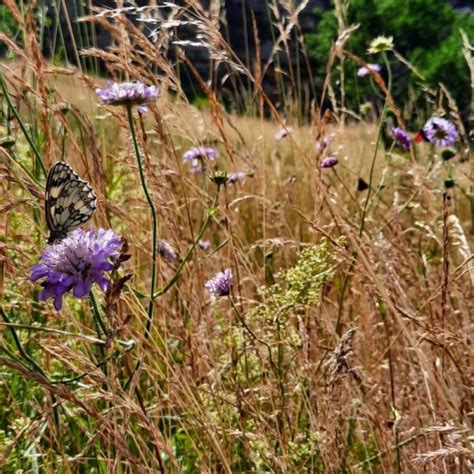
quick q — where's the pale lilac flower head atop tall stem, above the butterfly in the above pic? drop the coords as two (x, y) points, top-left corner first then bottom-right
(95, 82), (158, 112)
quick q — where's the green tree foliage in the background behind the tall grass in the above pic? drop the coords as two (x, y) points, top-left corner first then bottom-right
(306, 0), (474, 115)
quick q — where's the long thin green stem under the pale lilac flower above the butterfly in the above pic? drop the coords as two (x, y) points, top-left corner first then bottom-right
(127, 106), (158, 339)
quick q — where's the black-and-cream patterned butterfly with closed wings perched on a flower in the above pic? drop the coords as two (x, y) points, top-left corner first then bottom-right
(45, 162), (96, 244)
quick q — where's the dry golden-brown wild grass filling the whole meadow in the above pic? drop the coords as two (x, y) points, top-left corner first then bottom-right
(0, 1), (474, 473)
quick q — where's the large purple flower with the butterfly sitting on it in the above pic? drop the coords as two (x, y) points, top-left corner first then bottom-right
(30, 229), (123, 311)
